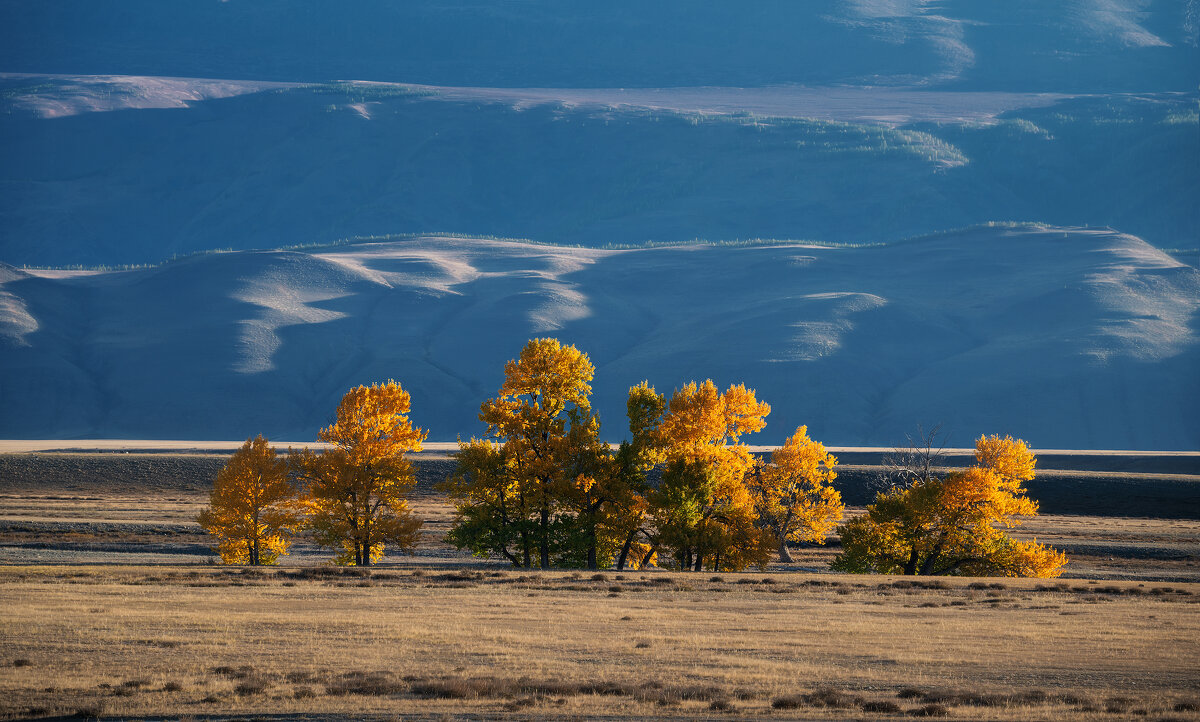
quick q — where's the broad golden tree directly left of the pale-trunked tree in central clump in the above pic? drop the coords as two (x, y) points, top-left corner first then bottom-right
(650, 380), (772, 571)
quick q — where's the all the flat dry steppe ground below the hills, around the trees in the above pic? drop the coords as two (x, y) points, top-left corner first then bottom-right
(0, 446), (1200, 720)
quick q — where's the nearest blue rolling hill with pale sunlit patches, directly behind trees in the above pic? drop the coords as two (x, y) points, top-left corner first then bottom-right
(0, 225), (1200, 450)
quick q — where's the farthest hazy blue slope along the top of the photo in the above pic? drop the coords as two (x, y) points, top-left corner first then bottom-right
(0, 0), (1200, 92)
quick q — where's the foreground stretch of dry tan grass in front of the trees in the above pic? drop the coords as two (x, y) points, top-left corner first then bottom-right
(0, 566), (1200, 720)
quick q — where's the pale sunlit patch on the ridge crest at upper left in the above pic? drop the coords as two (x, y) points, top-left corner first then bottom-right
(0, 73), (300, 118)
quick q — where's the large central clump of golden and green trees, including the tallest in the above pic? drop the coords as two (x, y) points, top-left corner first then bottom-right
(442, 338), (842, 571)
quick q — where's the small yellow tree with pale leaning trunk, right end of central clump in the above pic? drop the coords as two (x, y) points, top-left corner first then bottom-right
(750, 426), (844, 561)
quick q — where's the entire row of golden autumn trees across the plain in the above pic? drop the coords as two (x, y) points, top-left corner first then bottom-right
(199, 338), (1066, 577)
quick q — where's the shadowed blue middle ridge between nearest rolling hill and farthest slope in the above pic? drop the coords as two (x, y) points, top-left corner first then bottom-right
(0, 76), (1200, 265)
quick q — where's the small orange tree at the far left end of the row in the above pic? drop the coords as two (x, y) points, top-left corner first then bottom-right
(197, 435), (300, 566)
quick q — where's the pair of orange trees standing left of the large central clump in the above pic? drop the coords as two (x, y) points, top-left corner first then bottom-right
(197, 381), (426, 566)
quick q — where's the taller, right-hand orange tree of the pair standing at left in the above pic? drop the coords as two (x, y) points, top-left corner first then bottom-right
(292, 380), (426, 566)
